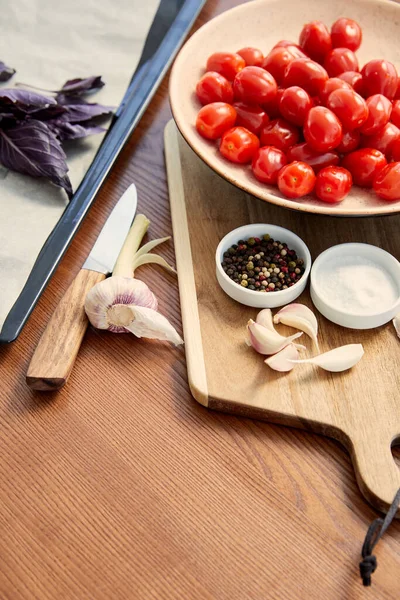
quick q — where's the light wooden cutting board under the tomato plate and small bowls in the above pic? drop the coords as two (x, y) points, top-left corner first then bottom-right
(165, 121), (400, 516)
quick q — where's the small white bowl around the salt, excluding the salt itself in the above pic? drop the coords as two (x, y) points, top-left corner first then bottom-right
(310, 243), (400, 329)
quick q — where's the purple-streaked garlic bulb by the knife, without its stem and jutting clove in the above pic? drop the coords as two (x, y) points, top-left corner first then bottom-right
(85, 275), (158, 333)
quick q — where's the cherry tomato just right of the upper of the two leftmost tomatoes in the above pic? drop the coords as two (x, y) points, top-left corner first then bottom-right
(233, 67), (278, 104)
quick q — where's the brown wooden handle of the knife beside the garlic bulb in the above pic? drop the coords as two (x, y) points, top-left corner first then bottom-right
(26, 269), (106, 391)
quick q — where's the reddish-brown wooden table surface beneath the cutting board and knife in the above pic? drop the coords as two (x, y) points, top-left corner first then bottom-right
(0, 0), (400, 600)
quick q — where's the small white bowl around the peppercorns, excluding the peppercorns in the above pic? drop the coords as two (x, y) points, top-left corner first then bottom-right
(215, 223), (311, 308)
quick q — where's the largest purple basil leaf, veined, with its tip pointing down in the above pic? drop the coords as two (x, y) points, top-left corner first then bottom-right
(0, 119), (72, 198)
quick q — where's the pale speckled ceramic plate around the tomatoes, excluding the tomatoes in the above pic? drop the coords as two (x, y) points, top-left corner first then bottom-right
(170, 0), (400, 216)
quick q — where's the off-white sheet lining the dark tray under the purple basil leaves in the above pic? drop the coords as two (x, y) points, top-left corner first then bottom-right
(0, 0), (159, 330)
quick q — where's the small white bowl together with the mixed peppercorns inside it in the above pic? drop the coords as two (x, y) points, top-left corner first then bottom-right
(215, 223), (311, 308)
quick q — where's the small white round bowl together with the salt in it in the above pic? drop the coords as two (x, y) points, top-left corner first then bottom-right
(310, 243), (400, 329)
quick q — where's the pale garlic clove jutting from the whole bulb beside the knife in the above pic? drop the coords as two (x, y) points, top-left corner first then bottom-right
(126, 306), (183, 346)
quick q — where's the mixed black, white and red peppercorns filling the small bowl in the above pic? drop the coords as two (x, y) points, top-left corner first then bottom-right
(221, 233), (304, 292)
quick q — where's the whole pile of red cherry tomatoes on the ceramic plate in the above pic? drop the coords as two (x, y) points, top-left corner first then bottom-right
(196, 18), (400, 204)
